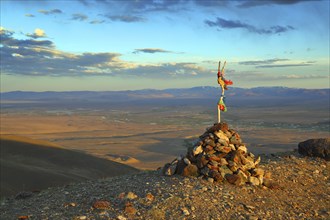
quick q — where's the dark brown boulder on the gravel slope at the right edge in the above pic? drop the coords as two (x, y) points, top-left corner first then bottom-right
(298, 138), (330, 161)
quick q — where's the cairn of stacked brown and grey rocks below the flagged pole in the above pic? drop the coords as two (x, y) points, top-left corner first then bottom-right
(163, 123), (264, 185)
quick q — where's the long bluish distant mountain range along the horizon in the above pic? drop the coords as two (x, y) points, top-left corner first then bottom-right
(0, 86), (330, 106)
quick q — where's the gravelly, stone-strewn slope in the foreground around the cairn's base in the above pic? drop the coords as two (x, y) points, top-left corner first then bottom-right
(0, 152), (330, 220)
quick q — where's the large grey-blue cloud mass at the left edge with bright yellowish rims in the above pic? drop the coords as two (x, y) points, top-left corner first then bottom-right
(0, 28), (119, 76)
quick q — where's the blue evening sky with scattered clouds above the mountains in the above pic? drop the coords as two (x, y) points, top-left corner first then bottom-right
(0, 0), (330, 92)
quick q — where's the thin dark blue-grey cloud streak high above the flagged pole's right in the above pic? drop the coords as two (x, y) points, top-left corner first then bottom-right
(204, 17), (294, 34)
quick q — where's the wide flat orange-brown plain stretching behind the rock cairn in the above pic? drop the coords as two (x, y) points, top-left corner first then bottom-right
(0, 89), (329, 170)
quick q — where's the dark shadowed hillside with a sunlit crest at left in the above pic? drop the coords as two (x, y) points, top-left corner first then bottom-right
(0, 135), (138, 197)
